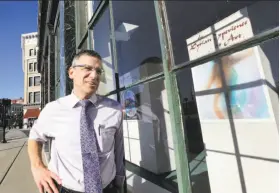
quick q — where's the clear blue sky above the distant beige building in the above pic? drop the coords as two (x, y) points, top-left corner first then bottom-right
(0, 0), (38, 99)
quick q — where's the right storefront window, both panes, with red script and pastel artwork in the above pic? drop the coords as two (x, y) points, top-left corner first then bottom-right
(165, 1), (279, 193)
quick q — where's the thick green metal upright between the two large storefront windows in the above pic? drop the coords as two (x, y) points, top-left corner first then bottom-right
(154, 1), (192, 193)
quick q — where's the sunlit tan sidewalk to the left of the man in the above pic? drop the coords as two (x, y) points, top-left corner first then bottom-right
(0, 129), (39, 193)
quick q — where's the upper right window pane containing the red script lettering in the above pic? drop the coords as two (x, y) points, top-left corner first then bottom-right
(166, 1), (279, 65)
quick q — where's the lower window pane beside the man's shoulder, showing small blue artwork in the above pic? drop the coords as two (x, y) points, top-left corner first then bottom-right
(120, 79), (178, 192)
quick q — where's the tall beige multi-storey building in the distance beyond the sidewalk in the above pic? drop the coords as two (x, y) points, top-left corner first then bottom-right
(21, 32), (41, 128)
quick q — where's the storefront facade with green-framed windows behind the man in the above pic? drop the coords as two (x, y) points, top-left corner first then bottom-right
(37, 0), (279, 193)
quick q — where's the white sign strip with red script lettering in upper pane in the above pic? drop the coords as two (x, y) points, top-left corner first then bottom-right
(186, 9), (254, 60)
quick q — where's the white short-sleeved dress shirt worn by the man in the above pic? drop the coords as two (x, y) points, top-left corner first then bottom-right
(29, 93), (125, 192)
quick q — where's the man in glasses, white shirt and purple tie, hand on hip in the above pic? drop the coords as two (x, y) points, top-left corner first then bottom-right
(28, 50), (125, 193)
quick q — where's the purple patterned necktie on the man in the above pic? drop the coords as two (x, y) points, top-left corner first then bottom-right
(80, 100), (102, 193)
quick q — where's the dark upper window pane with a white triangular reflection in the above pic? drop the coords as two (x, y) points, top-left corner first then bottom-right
(112, 1), (162, 86)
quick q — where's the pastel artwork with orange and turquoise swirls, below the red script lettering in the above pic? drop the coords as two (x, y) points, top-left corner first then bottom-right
(192, 44), (275, 119)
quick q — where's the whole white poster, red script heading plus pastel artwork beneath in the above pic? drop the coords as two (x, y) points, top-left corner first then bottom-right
(187, 8), (270, 120)
